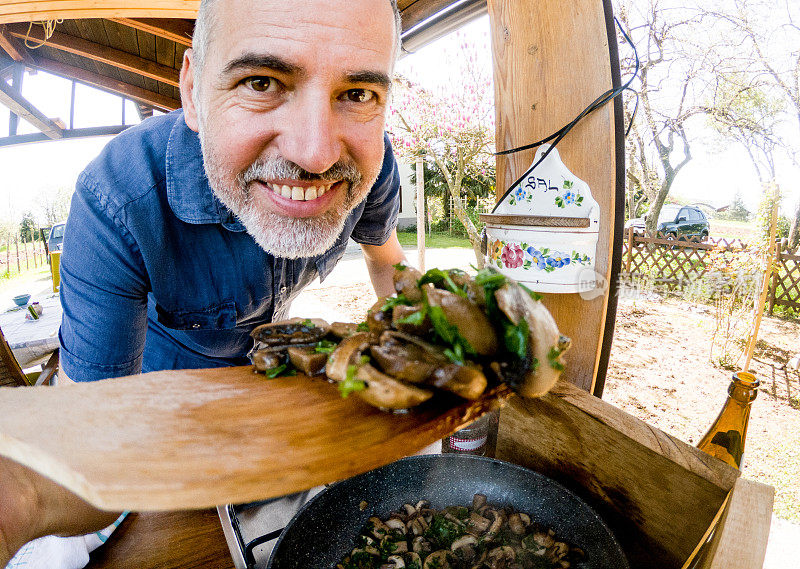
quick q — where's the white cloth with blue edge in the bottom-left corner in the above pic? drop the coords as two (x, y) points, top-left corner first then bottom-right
(6, 512), (128, 569)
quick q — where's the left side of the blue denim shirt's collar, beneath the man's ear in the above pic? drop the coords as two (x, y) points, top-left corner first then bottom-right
(166, 110), (245, 232)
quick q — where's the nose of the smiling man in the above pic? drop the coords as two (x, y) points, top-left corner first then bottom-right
(281, 93), (342, 174)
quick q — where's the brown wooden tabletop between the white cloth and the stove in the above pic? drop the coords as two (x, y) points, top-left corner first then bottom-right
(87, 509), (234, 569)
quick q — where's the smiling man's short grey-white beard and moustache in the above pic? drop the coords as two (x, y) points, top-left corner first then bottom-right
(200, 128), (380, 259)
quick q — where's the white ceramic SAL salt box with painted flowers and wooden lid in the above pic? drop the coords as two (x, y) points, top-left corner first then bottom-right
(481, 145), (600, 293)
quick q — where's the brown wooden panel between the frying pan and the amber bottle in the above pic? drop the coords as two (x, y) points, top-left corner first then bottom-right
(496, 381), (740, 569)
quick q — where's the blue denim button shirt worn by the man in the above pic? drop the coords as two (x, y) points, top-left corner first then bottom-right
(59, 111), (400, 381)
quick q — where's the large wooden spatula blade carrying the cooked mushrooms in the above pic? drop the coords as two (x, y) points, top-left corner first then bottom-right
(0, 367), (510, 510)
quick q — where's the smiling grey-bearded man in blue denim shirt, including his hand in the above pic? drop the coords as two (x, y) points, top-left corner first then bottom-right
(0, 0), (403, 567)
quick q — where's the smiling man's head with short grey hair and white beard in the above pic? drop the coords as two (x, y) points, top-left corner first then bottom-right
(181, 0), (397, 258)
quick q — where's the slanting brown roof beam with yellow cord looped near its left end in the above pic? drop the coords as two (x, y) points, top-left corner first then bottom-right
(7, 24), (178, 87)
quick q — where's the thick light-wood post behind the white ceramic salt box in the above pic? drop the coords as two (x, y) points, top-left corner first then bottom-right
(488, 0), (617, 391)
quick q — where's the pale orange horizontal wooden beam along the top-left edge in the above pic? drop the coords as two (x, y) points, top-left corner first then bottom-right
(0, 0), (200, 24)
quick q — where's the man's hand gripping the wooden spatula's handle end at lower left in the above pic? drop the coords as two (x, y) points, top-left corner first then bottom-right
(0, 457), (120, 567)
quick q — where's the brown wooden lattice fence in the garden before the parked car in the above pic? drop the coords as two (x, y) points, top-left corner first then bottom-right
(622, 229), (800, 314)
